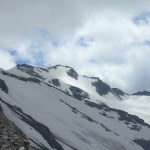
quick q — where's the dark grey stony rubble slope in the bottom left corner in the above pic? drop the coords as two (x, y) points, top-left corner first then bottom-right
(0, 106), (33, 150)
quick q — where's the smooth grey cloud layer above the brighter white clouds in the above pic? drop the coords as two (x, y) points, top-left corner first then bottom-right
(0, 0), (148, 39)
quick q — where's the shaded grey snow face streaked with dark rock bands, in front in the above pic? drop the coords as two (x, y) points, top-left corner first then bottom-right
(0, 71), (150, 150)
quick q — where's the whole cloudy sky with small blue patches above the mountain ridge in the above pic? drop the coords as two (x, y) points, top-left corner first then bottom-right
(0, 0), (150, 93)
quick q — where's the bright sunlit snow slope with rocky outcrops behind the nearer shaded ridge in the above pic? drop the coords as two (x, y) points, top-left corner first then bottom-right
(8, 64), (150, 124)
